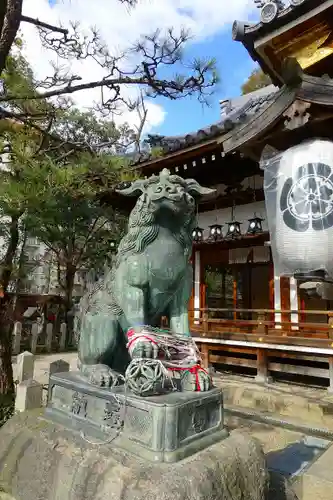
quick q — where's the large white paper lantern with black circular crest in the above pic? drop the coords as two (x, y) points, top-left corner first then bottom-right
(264, 140), (333, 276)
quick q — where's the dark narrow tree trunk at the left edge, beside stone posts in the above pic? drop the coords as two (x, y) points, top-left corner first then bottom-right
(0, 215), (20, 426)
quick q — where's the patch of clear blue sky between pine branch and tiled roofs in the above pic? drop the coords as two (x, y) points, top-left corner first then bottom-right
(153, 31), (255, 135)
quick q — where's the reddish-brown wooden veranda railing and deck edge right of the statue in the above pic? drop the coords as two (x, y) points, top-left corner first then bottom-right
(189, 308), (333, 390)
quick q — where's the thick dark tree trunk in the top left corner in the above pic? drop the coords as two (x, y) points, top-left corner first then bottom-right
(0, 0), (23, 75)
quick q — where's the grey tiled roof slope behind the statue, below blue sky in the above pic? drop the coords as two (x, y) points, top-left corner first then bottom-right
(136, 85), (278, 163)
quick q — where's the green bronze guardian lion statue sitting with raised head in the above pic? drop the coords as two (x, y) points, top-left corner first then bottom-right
(75, 169), (214, 386)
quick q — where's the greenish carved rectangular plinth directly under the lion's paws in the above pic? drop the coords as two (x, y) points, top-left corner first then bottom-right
(45, 372), (228, 463)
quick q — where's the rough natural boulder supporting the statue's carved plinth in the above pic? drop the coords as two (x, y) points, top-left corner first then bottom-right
(0, 411), (268, 500)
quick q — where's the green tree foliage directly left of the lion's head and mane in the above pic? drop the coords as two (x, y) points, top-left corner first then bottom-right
(26, 153), (125, 289)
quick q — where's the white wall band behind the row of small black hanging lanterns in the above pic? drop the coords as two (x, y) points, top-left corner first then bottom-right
(198, 201), (268, 237)
